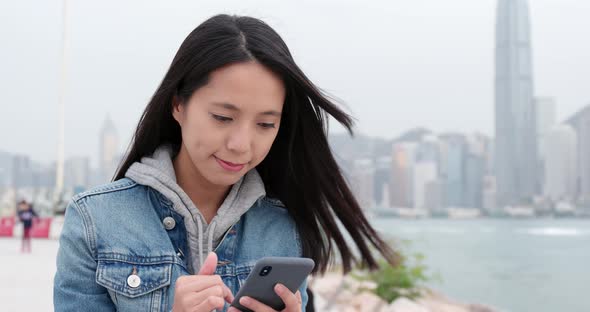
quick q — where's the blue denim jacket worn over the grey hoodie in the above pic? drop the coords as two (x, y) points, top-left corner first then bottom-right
(53, 178), (307, 312)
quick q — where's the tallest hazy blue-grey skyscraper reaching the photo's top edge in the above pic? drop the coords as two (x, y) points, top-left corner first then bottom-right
(495, 0), (538, 206)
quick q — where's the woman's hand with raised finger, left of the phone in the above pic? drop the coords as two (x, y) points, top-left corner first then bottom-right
(172, 252), (234, 312)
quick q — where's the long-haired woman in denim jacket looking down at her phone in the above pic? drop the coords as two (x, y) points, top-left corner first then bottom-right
(54, 15), (394, 311)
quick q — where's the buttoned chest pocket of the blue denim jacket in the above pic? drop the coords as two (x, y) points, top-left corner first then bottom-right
(96, 255), (174, 311)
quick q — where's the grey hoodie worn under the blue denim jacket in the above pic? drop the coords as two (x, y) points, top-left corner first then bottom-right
(125, 145), (266, 273)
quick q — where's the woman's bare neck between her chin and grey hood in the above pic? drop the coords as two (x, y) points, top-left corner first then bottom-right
(173, 145), (230, 223)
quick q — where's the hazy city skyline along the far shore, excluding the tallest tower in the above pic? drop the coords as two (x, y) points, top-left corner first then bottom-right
(0, 119), (590, 217)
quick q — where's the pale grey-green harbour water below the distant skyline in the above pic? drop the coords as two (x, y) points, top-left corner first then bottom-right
(371, 218), (590, 312)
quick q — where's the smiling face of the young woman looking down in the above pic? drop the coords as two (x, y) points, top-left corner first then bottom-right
(173, 62), (285, 186)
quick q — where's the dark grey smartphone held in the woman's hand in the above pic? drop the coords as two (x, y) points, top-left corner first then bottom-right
(231, 257), (315, 312)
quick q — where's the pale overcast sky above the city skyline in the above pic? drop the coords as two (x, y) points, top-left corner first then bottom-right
(0, 0), (590, 166)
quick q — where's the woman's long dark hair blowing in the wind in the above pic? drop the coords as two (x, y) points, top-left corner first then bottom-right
(114, 15), (397, 273)
